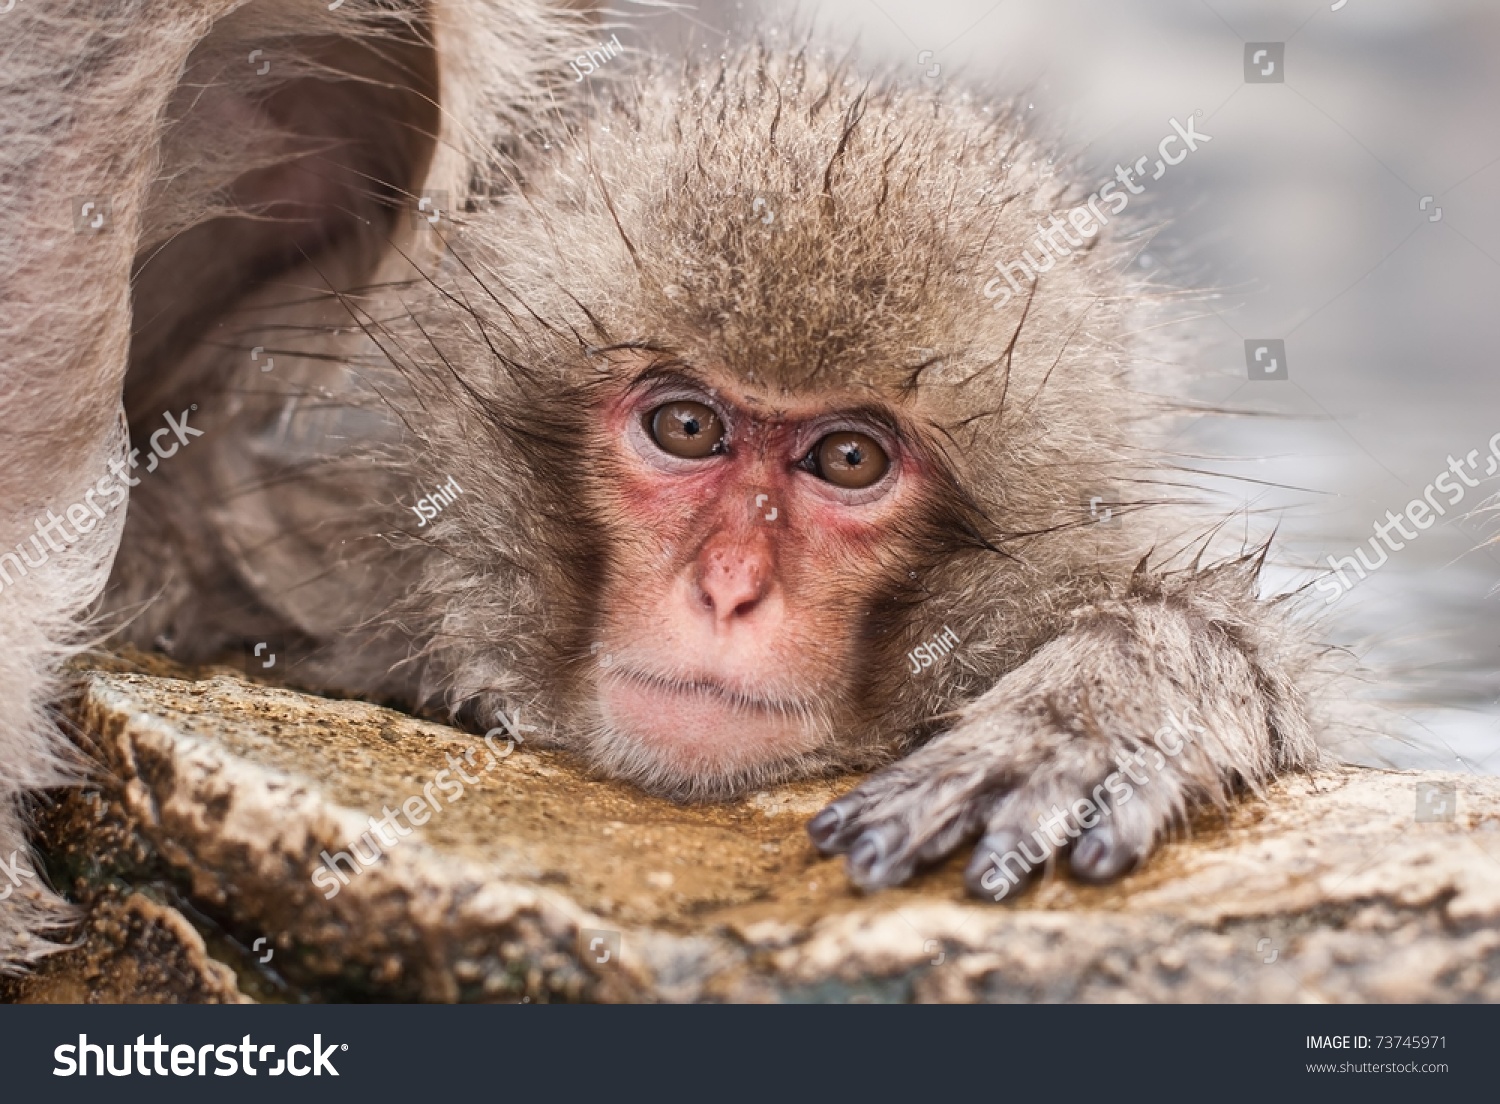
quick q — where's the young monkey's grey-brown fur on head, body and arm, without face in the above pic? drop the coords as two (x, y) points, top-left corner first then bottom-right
(5, 0), (1316, 966)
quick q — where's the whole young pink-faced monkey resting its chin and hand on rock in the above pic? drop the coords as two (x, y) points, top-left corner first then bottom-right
(99, 28), (1316, 897)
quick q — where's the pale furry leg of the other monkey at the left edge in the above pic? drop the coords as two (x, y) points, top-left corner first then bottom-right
(0, 0), (246, 971)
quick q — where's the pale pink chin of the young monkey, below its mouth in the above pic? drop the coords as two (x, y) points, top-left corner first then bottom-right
(593, 672), (827, 800)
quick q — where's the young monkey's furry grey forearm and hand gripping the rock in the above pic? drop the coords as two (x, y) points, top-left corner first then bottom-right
(809, 576), (1317, 900)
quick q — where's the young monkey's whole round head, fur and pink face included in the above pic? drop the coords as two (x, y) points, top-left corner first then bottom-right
(401, 51), (1122, 798)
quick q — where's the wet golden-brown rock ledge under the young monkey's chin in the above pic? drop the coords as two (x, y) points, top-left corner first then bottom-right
(8, 660), (1500, 1002)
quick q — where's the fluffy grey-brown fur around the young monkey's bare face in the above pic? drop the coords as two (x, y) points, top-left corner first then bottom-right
(325, 48), (1170, 797)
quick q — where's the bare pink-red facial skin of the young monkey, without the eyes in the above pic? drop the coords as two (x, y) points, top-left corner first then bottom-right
(596, 366), (926, 780)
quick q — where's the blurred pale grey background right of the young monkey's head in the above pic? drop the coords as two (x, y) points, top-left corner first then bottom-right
(636, 0), (1500, 774)
